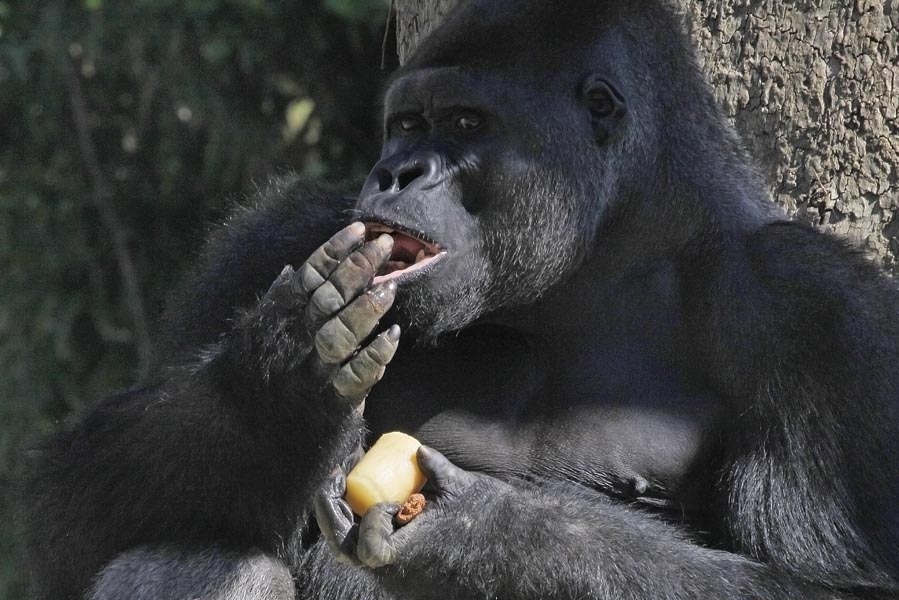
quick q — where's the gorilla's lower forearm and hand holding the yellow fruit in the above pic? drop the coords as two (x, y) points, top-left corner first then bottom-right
(316, 448), (842, 600)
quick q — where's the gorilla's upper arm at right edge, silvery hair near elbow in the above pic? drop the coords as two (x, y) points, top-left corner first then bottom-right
(698, 222), (899, 597)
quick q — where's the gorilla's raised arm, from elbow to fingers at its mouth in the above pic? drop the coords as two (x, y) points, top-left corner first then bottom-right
(26, 195), (399, 598)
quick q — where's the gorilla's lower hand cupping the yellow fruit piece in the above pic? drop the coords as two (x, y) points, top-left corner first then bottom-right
(315, 446), (515, 573)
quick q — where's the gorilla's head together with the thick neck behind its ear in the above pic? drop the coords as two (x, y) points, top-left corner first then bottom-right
(357, 0), (760, 336)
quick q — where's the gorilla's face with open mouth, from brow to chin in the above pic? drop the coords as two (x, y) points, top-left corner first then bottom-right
(357, 65), (623, 337)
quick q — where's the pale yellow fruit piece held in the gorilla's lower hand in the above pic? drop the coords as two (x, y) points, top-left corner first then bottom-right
(344, 431), (426, 517)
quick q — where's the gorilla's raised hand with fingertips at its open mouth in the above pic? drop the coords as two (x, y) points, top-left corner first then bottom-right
(232, 223), (400, 407)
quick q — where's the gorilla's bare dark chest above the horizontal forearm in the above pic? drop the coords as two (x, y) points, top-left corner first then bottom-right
(365, 331), (715, 509)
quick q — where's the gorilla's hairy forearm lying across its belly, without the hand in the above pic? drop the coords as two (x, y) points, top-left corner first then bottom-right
(384, 484), (843, 600)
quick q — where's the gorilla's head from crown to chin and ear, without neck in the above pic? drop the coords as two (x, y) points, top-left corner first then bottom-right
(357, 1), (633, 335)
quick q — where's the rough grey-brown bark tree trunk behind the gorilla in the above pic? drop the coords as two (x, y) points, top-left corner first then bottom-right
(395, 0), (899, 274)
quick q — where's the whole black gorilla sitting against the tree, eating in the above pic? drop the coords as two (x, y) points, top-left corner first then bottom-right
(21, 0), (899, 599)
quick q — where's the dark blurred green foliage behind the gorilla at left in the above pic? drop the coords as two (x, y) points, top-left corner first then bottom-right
(0, 0), (396, 599)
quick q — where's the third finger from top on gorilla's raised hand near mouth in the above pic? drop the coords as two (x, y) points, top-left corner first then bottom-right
(315, 281), (396, 365)
